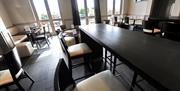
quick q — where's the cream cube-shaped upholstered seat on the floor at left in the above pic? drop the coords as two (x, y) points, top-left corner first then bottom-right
(16, 42), (34, 57)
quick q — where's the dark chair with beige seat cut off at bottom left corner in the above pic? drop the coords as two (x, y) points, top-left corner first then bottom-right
(0, 52), (34, 91)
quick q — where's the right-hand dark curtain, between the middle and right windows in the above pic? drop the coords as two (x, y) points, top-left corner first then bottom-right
(94, 0), (102, 23)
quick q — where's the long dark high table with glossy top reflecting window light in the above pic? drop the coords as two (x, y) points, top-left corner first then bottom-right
(80, 24), (180, 91)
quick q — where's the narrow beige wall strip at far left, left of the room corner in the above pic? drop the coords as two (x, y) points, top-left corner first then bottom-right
(0, 0), (13, 27)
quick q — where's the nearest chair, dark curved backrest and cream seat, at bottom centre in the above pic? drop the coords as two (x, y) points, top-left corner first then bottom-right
(54, 59), (128, 91)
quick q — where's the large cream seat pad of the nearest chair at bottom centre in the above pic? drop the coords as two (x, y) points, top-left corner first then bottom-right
(74, 70), (128, 91)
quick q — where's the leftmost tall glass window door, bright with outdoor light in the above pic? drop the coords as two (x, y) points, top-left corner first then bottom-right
(32, 0), (62, 32)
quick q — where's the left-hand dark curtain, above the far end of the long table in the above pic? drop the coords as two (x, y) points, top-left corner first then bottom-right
(71, 0), (81, 26)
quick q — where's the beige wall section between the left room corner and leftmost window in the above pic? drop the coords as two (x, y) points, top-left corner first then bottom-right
(3, 0), (35, 25)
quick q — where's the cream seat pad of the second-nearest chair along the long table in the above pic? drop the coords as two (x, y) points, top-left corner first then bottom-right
(68, 43), (92, 57)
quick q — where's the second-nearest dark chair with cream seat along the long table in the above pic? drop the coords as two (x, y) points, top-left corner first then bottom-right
(59, 35), (92, 79)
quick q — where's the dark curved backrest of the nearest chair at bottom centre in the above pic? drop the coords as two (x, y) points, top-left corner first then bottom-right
(54, 59), (75, 91)
